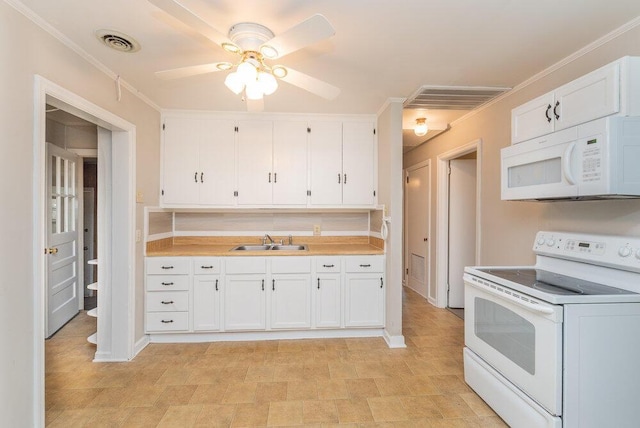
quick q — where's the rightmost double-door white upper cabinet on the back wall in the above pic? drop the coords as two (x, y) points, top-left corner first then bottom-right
(309, 122), (375, 206)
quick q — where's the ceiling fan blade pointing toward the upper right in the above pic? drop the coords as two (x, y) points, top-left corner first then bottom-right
(263, 14), (336, 59)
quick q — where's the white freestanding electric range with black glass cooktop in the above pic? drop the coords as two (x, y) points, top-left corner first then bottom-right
(464, 232), (640, 428)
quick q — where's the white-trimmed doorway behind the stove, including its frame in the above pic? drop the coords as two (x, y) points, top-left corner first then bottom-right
(435, 140), (482, 309)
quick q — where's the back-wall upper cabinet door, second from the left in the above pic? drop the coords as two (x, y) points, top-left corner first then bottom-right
(198, 119), (236, 205)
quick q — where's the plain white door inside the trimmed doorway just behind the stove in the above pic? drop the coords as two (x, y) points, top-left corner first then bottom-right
(447, 159), (476, 308)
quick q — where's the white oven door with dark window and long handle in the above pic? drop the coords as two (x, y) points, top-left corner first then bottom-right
(464, 273), (563, 416)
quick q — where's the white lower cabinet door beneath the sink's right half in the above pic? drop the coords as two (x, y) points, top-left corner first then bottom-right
(269, 274), (311, 329)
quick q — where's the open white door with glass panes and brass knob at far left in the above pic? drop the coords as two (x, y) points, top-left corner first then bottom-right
(45, 144), (80, 337)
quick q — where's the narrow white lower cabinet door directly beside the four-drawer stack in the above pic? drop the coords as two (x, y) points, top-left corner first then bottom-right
(193, 275), (222, 331)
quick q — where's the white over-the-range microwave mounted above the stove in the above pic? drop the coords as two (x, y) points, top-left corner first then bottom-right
(500, 117), (640, 200)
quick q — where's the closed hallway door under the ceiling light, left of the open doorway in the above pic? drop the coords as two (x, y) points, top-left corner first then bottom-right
(405, 165), (431, 298)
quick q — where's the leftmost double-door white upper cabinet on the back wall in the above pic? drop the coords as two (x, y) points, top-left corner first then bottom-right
(162, 115), (235, 206)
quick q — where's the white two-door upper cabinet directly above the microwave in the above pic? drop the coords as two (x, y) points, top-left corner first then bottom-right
(511, 57), (640, 144)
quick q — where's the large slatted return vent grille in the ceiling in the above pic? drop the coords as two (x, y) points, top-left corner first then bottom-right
(404, 86), (511, 110)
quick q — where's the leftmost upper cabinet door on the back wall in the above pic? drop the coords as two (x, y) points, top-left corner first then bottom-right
(162, 117), (203, 205)
